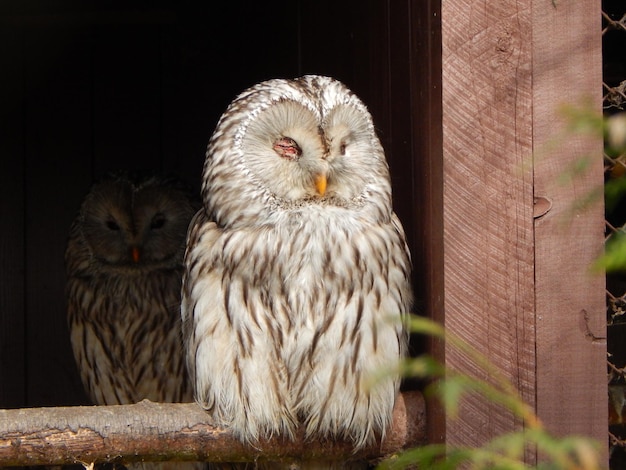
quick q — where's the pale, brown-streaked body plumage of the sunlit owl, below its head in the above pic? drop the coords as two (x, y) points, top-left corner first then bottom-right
(182, 206), (412, 446)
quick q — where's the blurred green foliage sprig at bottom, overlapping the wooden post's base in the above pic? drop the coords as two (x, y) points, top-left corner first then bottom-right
(378, 316), (602, 470)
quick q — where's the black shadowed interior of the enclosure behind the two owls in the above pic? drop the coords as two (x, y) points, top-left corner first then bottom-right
(0, 0), (441, 408)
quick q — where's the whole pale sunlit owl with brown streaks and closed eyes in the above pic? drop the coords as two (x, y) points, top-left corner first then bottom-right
(181, 76), (412, 466)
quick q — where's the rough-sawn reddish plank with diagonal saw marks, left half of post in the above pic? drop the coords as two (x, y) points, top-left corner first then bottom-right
(441, 0), (535, 446)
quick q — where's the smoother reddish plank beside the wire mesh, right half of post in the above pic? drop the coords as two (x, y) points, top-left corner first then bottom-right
(532, 0), (607, 443)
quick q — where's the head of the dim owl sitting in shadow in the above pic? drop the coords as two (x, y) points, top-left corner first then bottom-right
(75, 172), (198, 270)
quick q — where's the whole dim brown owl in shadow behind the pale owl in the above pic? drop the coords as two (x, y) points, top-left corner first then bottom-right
(65, 173), (197, 405)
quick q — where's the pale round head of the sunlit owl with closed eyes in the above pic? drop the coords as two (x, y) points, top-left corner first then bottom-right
(202, 75), (391, 225)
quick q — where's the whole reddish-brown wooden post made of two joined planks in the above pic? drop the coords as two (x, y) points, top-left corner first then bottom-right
(430, 0), (607, 464)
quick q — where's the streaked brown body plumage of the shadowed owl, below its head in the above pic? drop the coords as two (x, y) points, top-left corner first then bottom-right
(68, 260), (193, 405)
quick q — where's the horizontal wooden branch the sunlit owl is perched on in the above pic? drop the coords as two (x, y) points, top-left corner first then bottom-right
(0, 392), (425, 466)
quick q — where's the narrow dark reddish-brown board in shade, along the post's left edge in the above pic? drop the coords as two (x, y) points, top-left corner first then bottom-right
(410, 0), (447, 443)
